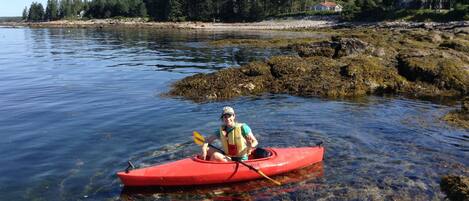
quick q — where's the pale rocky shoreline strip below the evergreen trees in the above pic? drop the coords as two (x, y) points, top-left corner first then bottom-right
(0, 18), (469, 30)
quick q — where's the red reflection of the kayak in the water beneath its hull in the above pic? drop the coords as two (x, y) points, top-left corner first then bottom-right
(120, 162), (324, 200)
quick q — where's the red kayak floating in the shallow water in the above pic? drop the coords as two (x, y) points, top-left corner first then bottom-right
(117, 146), (324, 186)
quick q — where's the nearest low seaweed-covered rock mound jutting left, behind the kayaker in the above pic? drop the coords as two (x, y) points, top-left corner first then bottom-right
(170, 53), (408, 101)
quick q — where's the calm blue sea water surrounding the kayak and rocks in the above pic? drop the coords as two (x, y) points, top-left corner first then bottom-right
(0, 27), (469, 200)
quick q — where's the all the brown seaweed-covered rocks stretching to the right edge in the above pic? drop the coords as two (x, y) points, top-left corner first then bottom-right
(169, 29), (469, 130)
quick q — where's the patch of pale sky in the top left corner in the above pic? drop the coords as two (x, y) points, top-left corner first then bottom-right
(0, 0), (47, 17)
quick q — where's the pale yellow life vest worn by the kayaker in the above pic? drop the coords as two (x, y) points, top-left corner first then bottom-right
(220, 123), (247, 157)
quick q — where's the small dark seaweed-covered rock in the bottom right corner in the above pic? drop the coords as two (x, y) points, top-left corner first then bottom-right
(440, 175), (469, 201)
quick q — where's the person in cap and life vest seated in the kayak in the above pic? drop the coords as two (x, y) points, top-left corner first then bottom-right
(202, 106), (258, 162)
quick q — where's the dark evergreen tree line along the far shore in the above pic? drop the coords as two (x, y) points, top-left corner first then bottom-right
(23, 0), (469, 22)
